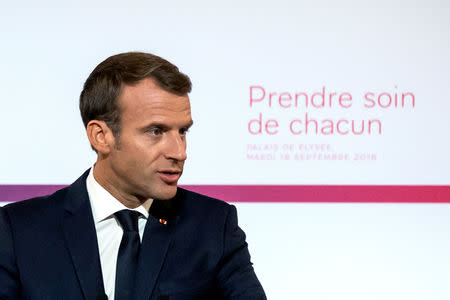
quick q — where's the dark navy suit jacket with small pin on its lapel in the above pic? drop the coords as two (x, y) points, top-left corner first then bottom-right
(0, 172), (266, 300)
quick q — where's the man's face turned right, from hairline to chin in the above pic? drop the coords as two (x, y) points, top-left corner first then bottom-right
(107, 79), (192, 200)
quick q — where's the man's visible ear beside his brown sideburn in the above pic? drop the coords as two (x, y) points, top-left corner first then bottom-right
(86, 120), (115, 155)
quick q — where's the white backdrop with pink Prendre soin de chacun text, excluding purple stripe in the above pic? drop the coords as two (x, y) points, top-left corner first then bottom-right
(0, 0), (450, 300)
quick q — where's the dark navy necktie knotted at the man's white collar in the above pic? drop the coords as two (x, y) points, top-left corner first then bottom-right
(114, 209), (141, 300)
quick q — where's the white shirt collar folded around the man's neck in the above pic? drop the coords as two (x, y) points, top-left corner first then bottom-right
(86, 167), (148, 223)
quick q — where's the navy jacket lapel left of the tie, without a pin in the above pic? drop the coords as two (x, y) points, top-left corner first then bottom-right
(62, 171), (105, 300)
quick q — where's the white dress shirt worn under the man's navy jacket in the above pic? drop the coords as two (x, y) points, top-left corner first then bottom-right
(86, 167), (148, 300)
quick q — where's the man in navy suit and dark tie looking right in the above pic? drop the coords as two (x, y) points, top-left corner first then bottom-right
(0, 52), (266, 300)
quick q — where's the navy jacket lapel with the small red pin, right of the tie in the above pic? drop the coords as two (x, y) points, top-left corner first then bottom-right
(134, 199), (179, 300)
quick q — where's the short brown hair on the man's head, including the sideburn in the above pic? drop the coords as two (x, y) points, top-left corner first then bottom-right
(80, 52), (192, 136)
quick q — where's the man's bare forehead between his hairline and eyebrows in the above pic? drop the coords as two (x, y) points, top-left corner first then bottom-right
(119, 78), (191, 122)
